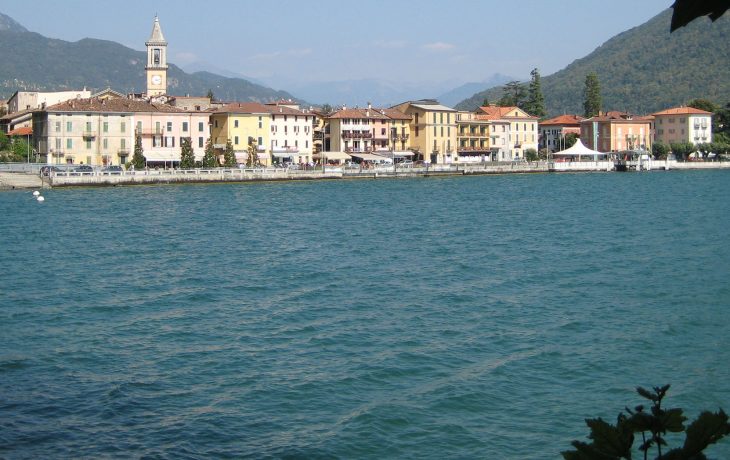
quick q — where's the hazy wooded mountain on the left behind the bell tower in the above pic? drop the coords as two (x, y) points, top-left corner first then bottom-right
(0, 14), (296, 102)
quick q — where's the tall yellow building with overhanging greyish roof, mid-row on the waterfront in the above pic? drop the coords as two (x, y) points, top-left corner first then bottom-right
(391, 99), (457, 164)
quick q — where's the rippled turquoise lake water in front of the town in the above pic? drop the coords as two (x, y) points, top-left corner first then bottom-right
(0, 171), (730, 459)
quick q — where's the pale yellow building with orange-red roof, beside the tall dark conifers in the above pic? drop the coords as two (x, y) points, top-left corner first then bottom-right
(476, 105), (538, 160)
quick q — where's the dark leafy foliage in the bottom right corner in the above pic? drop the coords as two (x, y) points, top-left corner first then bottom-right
(562, 385), (730, 460)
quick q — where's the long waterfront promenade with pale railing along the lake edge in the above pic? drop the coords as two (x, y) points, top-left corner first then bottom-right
(0, 160), (730, 189)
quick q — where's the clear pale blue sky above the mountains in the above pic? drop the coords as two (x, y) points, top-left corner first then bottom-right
(0, 0), (673, 89)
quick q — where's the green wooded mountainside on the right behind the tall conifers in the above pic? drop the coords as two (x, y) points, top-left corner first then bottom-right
(456, 10), (730, 115)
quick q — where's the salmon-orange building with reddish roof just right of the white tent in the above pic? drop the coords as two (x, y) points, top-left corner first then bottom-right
(580, 111), (653, 152)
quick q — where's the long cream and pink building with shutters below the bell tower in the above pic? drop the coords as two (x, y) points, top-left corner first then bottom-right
(33, 98), (208, 166)
